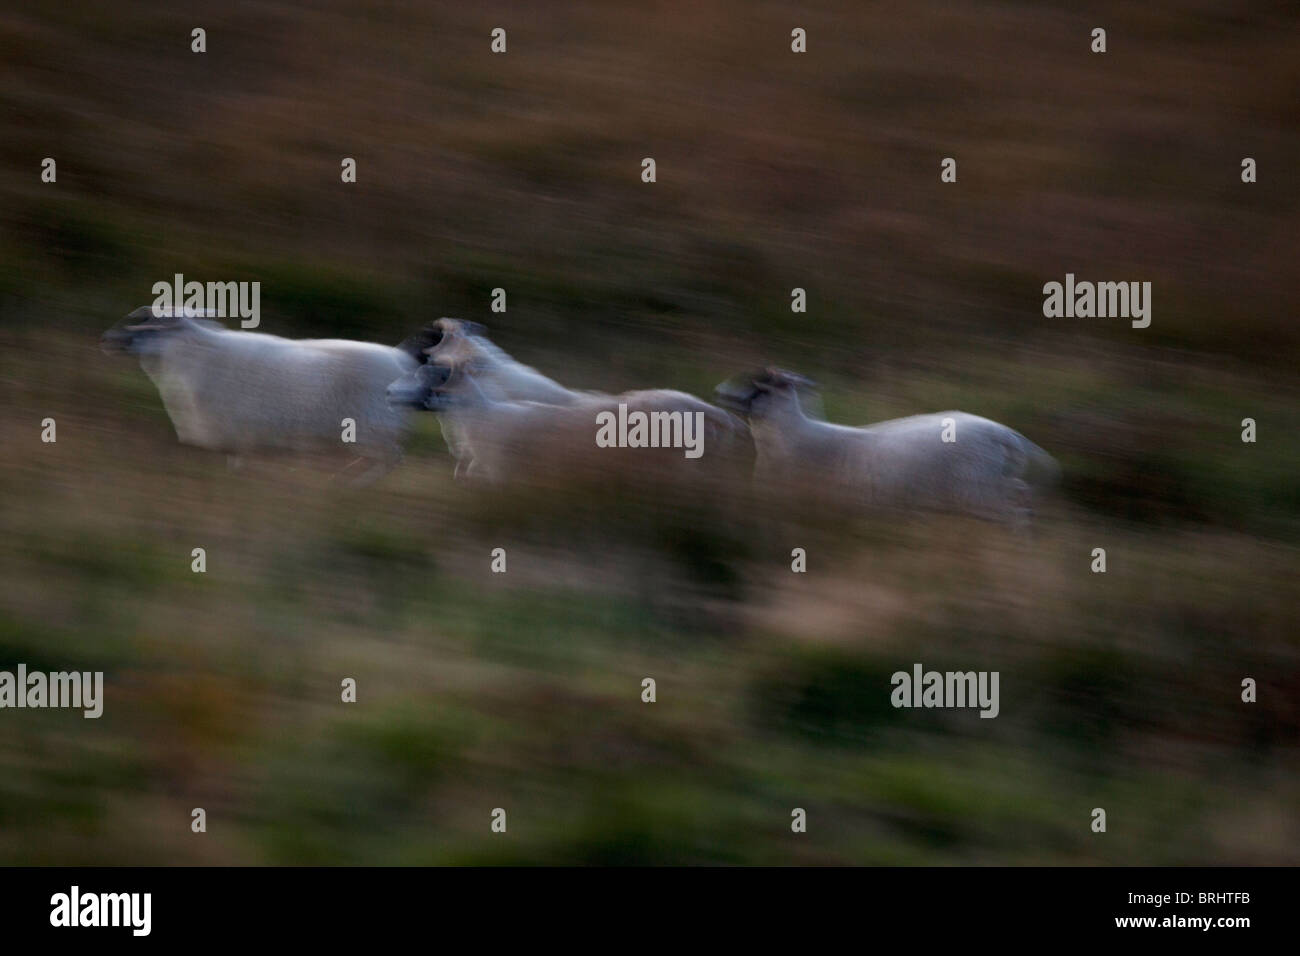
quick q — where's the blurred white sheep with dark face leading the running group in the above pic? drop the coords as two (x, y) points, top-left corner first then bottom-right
(101, 306), (423, 483)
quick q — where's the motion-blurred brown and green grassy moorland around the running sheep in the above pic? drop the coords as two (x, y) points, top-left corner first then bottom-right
(0, 0), (1300, 864)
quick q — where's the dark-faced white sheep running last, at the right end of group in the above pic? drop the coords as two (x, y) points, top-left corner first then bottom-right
(718, 368), (1058, 524)
